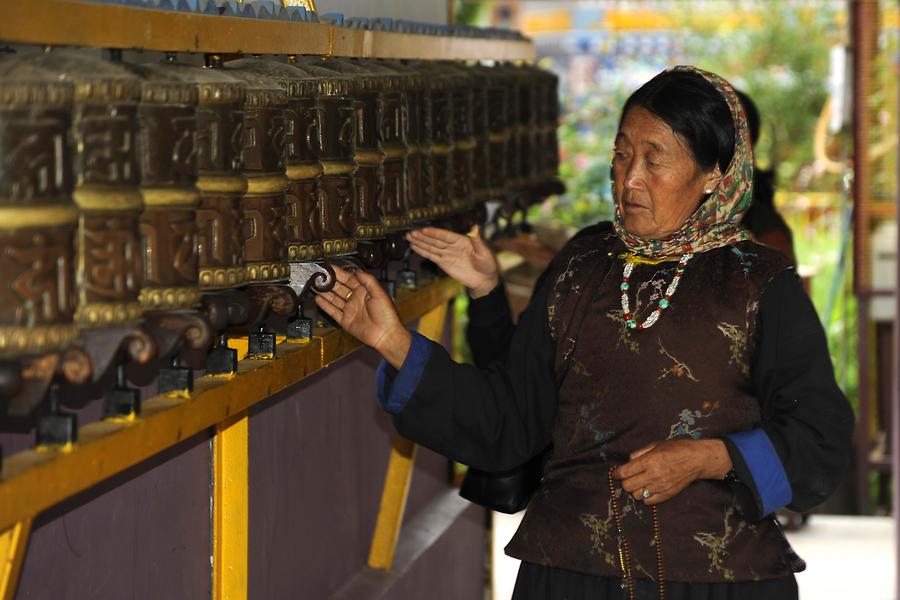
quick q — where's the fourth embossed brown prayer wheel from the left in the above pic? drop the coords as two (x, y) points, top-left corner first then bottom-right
(158, 62), (247, 290)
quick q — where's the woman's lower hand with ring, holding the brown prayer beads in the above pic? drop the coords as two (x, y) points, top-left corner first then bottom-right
(613, 439), (731, 504)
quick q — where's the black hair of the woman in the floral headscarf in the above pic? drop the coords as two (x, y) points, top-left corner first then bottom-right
(622, 71), (735, 173)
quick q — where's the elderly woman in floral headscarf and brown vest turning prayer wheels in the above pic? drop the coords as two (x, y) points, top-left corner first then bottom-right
(318, 67), (853, 600)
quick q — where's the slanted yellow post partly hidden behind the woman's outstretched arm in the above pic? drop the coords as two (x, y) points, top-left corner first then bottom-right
(368, 303), (447, 571)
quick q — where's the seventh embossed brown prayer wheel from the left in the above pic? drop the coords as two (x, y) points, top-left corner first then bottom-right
(292, 57), (357, 257)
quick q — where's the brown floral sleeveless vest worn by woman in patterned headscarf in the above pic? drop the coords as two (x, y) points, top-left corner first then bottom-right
(506, 228), (790, 582)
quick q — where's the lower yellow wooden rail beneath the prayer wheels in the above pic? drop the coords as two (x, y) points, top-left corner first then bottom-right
(0, 279), (461, 532)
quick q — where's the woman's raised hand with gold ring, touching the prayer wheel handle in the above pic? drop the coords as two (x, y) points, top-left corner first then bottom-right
(316, 267), (412, 369)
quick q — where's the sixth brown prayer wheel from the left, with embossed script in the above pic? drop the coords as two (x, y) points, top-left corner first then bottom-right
(229, 58), (323, 262)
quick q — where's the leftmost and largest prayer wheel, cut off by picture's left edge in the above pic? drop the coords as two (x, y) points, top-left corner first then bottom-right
(0, 57), (78, 358)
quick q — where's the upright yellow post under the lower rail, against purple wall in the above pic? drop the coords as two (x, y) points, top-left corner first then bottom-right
(213, 411), (250, 600)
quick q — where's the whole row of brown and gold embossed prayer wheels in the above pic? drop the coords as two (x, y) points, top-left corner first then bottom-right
(0, 49), (559, 438)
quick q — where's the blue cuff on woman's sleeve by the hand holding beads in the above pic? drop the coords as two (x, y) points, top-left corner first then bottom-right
(726, 429), (794, 516)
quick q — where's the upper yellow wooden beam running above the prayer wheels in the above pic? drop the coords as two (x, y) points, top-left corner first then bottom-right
(0, 0), (535, 60)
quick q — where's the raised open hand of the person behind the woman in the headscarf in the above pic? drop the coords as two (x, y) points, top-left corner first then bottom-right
(406, 225), (499, 298)
